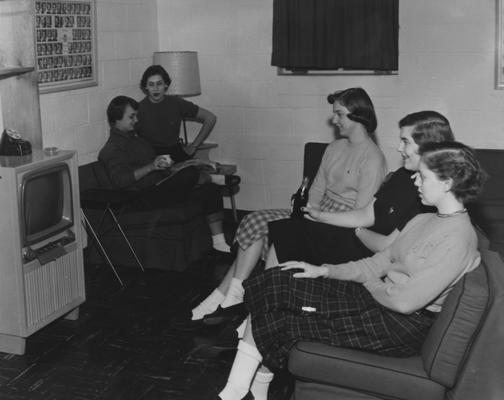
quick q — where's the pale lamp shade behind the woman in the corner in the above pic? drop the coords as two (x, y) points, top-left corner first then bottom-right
(154, 51), (201, 96)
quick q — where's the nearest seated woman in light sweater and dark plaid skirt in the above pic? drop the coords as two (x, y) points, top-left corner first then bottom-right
(218, 142), (484, 400)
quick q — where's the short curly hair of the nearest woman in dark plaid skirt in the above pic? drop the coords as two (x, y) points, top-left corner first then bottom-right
(419, 142), (487, 203)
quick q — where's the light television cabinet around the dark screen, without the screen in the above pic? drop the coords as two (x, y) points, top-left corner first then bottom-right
(0, 149), (86, 355)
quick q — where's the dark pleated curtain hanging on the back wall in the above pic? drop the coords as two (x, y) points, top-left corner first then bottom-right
(271, 0), (399, 70)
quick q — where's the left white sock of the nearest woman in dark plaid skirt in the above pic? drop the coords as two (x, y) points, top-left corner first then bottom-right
(219, 340), (262, 400)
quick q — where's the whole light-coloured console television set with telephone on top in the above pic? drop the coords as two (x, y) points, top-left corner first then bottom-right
(0, 149), (85, 354)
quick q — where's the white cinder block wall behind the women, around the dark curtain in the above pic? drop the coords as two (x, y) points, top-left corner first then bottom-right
(41, 0), (504, 209)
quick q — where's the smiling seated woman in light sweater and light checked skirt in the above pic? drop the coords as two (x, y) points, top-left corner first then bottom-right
(192, 88), (386, 320)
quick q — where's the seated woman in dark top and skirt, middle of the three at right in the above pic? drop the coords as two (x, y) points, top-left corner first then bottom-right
(267, 111), (454, 266)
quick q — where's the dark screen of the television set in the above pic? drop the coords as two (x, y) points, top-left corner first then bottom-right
(21, 165), (72, 245)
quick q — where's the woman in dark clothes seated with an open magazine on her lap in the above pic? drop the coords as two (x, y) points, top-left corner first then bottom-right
(98, 96), (227, 250)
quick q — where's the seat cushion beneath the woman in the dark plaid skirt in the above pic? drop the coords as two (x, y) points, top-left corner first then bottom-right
(289, 342), (445, 400)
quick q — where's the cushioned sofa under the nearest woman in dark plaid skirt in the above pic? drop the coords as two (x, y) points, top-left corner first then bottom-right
(288, 144), (504, 400)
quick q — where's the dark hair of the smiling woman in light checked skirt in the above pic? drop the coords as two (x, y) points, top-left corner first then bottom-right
(327, 87), (378, 134)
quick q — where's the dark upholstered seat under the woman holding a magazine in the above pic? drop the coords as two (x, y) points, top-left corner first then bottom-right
(79, 161), (212, 271)
